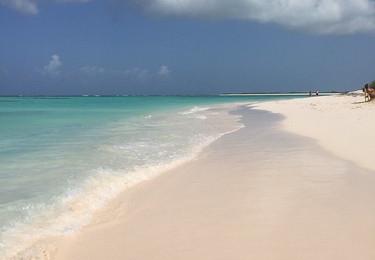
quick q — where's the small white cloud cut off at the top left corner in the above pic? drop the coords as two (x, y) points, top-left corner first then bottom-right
(0, 0), (91, 15)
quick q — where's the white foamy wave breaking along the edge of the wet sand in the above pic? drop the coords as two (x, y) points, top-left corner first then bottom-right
(0, 115), (244, 259)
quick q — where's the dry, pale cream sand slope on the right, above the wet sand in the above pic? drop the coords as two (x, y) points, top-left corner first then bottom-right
(256, 95), (375, 170)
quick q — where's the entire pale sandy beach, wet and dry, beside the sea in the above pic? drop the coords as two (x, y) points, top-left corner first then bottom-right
(54, 97), (375, 260)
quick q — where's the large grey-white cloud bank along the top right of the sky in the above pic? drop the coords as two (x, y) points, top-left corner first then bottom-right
(143, 0), (375, 34)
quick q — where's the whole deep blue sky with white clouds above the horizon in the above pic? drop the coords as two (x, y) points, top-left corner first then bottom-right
(0, 0), (375, 95)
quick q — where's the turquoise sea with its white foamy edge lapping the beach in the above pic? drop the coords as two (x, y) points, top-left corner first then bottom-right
(0, 96), (300, 258)
